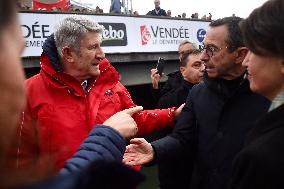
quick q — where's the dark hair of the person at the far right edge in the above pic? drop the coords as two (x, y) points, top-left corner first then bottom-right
(240, 0), (284, 57)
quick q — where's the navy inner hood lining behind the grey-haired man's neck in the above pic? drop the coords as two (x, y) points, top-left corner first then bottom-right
(42, 34), (63, 72)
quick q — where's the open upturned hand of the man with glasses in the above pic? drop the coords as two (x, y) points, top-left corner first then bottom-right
(123, 138), (154, 166)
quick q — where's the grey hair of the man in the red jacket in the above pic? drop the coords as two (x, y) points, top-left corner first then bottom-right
(54, 16), (104, 57)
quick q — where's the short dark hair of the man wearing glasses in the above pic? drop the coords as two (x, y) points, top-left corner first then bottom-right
(209, 16), (244, 52)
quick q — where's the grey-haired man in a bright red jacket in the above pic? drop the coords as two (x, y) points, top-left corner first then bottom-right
(9, 16), (180, 169)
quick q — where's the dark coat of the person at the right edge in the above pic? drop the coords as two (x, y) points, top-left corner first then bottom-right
(229, 105), (284, 189)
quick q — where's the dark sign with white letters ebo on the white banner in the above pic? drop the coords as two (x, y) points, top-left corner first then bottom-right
(99, 22), (127, 47)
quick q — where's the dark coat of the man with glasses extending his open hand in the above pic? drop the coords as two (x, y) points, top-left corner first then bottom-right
(151, 73), (270, 189)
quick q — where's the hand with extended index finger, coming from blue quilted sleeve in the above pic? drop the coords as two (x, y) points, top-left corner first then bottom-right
(103, 106), (143, 138)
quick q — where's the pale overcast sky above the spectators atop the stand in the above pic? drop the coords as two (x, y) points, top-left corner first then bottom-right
(80, 0), (267, 19)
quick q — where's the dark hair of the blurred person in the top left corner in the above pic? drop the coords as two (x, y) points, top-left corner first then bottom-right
(0, 0), (17, 32)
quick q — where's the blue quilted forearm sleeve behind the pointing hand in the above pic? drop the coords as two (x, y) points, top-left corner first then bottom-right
(59, 125), (126, 174)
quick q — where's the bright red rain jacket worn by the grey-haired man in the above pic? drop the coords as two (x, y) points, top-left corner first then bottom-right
(12, 54), (175, 169)
